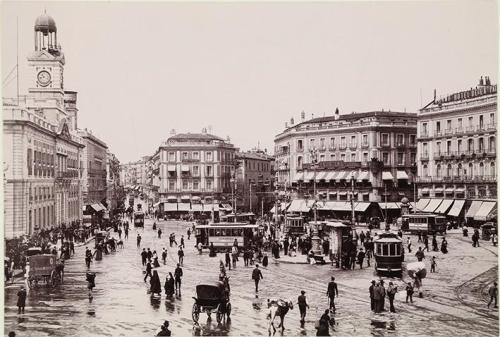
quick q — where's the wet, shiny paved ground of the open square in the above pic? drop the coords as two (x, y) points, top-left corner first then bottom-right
(5, 219), (498, 337)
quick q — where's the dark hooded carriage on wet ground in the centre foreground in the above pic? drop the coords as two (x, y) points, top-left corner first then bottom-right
(192, 282), (231, 323)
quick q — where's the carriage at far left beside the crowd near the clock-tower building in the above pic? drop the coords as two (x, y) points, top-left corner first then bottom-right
(28, 254), (64, 288)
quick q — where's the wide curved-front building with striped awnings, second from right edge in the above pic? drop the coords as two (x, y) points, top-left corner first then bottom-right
(274, 109), (417, 202)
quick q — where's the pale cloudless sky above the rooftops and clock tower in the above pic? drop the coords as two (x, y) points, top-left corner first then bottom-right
(2, 0), (498, 163)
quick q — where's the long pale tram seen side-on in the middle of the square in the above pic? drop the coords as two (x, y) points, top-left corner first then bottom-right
(196, 222), (262, 250)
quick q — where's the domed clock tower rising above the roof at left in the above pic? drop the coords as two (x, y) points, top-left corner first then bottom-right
(28, 13), (65, 104)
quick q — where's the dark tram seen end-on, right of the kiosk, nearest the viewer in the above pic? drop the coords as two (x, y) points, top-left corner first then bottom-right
(373, 232), (404, 277)
